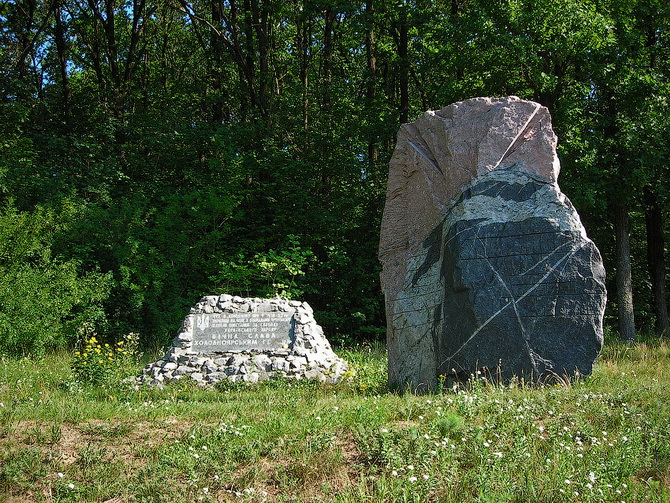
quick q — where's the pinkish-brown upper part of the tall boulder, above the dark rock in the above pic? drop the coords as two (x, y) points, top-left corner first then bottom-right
(379, 96), (560, 308)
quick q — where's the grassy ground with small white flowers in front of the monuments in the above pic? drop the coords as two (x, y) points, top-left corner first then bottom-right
(0, 340), (670, 503)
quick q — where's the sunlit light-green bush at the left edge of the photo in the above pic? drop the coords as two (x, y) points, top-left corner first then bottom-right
(0, 208), (109, 355)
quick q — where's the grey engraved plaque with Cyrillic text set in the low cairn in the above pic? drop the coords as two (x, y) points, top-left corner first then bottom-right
(192, 312), (293, 353)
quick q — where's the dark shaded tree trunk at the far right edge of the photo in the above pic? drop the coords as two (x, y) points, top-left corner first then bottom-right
(645, 189), (670, 336)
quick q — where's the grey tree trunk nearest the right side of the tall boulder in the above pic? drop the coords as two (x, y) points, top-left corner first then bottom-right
(614, 204), (635, 341)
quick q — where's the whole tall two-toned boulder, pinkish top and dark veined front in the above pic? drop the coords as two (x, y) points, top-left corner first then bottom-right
(379, 97), (606, 391)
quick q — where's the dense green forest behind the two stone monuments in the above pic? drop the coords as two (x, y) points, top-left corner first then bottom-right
(0, 0), (670, 354)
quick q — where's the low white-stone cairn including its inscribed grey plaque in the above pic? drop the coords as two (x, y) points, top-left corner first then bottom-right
(140, 294), (348, 385)
